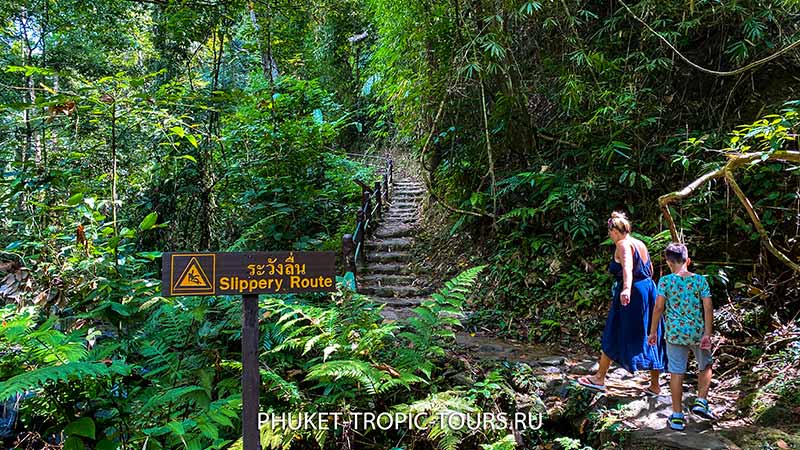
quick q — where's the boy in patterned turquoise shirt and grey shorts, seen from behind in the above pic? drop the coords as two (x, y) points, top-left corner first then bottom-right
(648, 243), (714, 431)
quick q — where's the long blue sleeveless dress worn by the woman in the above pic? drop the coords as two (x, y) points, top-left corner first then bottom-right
(602, 245), (667, 373)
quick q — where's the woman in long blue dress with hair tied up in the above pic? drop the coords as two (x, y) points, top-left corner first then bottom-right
(578, 211), (666, 395)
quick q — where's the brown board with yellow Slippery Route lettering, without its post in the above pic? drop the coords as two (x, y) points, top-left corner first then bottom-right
(161, 252), (336, 297)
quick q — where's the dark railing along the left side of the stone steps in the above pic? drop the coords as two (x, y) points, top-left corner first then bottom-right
(342, 153), (394, 290)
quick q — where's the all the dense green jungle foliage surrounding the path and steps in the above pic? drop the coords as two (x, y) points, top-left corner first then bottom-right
(0, 0), (800, 449)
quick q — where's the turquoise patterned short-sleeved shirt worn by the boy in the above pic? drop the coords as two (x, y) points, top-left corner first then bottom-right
(658, 273), (711, 345)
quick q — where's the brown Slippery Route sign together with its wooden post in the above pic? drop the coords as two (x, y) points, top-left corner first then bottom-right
(161, 252), (336, 450)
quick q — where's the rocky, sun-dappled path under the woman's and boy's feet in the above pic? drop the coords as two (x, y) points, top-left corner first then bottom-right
(457, 333), (800, 450)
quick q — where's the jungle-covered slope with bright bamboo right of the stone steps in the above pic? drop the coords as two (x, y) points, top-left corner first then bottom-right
(360, 0), (800, 339)
